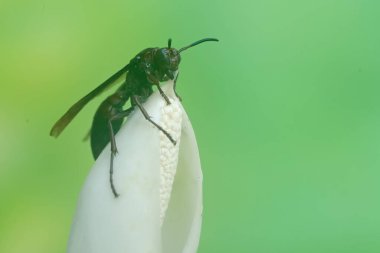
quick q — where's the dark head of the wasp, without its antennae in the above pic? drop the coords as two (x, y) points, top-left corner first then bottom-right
(154, 48), (181, 80)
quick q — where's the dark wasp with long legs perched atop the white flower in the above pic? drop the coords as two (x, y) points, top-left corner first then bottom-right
(50, 38), (218, 197)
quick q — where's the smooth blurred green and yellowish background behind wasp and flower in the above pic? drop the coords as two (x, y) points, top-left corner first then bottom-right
(0, 0), (380, 253)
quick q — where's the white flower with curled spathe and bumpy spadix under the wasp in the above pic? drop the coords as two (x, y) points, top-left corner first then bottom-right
(68, 78), (202, 253)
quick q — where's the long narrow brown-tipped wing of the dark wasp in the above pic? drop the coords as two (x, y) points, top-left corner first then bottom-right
(50, 64), (129, 137)
